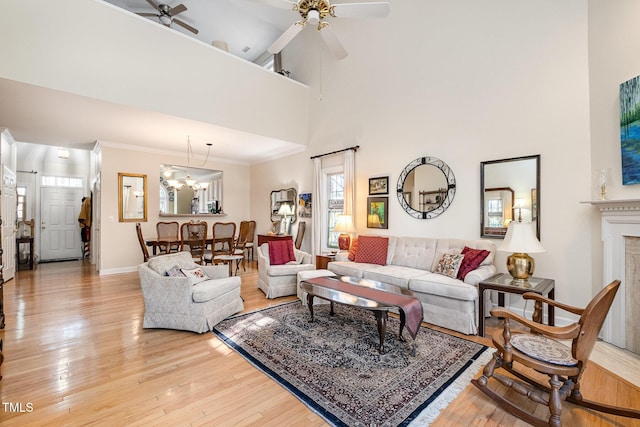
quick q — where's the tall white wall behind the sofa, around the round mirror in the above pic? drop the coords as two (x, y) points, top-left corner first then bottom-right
(251, 0), (592, 312)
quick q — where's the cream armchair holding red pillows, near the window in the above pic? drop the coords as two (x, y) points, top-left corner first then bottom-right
(256, 241), (316, 298)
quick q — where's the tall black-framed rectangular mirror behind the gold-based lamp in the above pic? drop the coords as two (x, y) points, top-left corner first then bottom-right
(480, 154), (540, 239)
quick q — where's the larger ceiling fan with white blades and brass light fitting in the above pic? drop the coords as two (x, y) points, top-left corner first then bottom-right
(264, 0), (389, 59)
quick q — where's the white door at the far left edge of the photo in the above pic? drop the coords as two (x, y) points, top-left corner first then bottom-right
(2, 164), (17, 281)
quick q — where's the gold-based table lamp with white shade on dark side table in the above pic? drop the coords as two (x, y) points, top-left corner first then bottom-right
(498, 221), (546, 282)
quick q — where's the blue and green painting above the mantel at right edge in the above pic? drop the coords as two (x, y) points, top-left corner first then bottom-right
(620, 76), (640, 185)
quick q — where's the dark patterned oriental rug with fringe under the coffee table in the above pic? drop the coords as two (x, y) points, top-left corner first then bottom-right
(213, 301), (491, 427)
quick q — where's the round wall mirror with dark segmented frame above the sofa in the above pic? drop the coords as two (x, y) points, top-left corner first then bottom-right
(397, 157), (456, 219)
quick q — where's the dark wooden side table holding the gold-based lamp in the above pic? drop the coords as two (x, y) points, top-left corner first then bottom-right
(478, 273), (556, 337)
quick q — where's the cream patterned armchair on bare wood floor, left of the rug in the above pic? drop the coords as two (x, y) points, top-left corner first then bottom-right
(138, 252), (244, 333)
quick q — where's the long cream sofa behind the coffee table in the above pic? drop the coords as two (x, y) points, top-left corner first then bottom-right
(327, 236), (496, 335)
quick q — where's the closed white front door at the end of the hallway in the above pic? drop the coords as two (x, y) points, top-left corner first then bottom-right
(40, 187), (83, 261)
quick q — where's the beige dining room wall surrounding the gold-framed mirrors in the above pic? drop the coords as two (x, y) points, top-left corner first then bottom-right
(98, 143), (251, 274)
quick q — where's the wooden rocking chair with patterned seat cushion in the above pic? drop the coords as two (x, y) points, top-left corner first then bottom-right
(472, 280), (640, 427)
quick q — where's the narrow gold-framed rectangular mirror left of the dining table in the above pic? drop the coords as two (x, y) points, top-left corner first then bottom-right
(118, 173), (147, 222)
